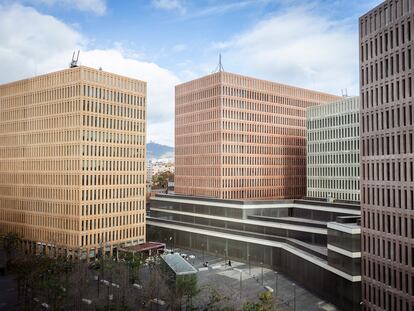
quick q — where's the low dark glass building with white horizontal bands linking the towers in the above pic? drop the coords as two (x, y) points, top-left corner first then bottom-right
(147, 194), (361, 311)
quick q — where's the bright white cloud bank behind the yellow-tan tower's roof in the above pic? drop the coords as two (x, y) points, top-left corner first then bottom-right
(0, 5), (180, 145)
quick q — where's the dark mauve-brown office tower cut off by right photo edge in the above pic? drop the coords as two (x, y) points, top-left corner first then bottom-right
(359, 0), (414, 311)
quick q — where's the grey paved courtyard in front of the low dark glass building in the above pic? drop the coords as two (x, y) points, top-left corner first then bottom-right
(174, 249), (338, 311)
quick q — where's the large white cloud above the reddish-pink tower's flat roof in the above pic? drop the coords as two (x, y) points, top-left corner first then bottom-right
(217, 7), (358, 94)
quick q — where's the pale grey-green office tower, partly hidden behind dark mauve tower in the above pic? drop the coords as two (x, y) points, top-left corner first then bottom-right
(306, 97), (360, 201)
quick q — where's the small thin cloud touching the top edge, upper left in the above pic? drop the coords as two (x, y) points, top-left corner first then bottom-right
(23, 0), (106, 15)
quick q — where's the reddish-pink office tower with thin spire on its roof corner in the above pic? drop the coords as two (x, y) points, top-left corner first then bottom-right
(175, 71), (339, 199)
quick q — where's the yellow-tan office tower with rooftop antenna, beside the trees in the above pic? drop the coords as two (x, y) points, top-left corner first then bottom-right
(0, 67), (146, 257)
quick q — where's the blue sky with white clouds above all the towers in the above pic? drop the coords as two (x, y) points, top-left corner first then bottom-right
(0, 0), (382, 146)
